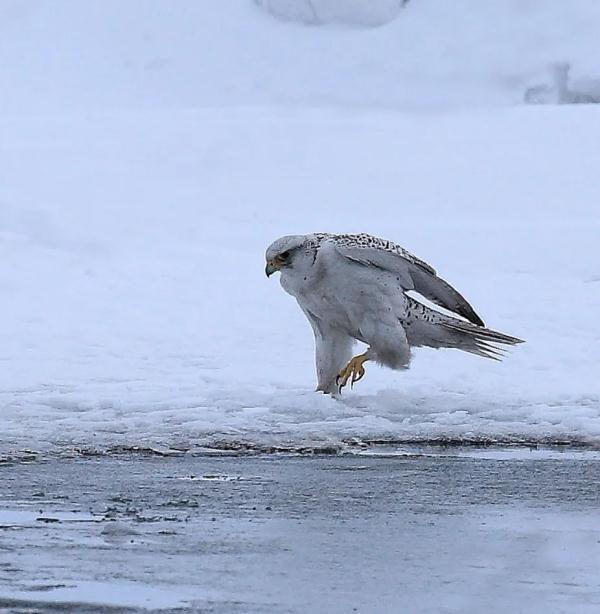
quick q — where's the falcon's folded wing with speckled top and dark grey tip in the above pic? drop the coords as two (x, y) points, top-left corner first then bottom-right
(330, 234), (484, 326)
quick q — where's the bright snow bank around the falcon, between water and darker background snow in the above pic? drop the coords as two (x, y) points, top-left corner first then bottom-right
(0, 106), (600, 452)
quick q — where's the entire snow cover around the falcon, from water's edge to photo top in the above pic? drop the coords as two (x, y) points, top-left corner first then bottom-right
(0, 0), (600, 454)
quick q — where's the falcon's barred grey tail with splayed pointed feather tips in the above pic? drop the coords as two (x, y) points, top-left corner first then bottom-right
(403, 298), (524, 360)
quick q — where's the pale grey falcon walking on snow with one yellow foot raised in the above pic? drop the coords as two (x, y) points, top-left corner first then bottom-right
(265, 233), (523, 396)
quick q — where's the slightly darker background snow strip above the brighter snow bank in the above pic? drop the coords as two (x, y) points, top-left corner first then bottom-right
(0, 0), (600, 113)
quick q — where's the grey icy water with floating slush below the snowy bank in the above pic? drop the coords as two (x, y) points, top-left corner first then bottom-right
(0, 448), (600, 613)
